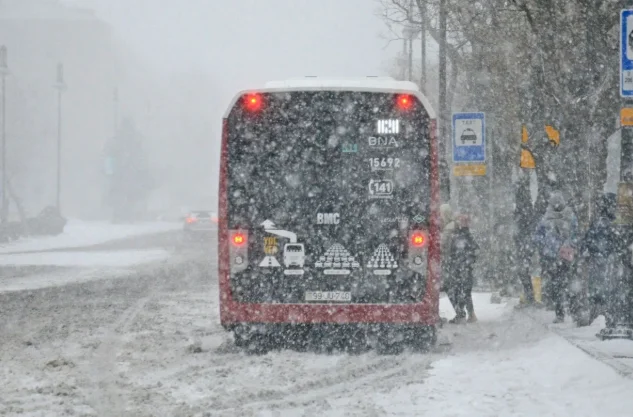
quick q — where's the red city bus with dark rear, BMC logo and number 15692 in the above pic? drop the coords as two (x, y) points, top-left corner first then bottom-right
(218, 77), (440, 349)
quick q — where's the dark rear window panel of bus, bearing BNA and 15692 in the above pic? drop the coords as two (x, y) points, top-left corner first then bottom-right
(228, 91), (430, 231)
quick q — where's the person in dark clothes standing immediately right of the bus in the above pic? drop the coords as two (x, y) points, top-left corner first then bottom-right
(450, 214), (479, 323)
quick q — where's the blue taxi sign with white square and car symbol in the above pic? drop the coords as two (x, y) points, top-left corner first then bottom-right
(453, 113), (486, 163)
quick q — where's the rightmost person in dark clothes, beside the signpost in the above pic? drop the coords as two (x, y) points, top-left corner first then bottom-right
(579, 193), (617, 326)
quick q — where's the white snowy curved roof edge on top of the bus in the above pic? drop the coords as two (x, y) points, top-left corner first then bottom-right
(224, 76), (436, 119)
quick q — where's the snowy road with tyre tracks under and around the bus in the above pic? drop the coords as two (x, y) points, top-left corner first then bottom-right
(0, 234), (633, 417)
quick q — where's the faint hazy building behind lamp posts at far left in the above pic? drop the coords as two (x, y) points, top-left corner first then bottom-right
(0, 0), (123, 218)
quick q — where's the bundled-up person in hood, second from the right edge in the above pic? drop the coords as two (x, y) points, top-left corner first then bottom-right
(533, 191), (578, 323)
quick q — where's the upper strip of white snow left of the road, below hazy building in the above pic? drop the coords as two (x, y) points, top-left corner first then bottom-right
(0, 220), (182, 253)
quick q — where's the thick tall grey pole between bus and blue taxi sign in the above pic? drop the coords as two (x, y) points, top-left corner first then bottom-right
(439, 0), (451, 202)
